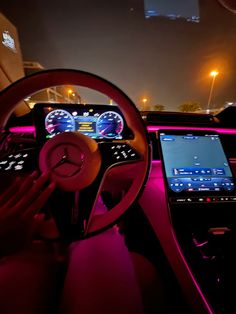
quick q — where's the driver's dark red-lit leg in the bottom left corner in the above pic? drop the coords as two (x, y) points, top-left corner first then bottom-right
(0, 242), (62, 314)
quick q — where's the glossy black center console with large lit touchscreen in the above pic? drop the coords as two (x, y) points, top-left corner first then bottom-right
(158, 130), (236, 313)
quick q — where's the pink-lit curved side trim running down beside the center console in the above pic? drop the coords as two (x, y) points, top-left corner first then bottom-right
(144, 160), (214, 314)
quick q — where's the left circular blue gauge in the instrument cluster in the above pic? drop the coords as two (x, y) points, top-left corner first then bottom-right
(45, 109), (75, 136)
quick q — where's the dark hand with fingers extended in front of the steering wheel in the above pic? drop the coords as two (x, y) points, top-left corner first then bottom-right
(0, 172), (55, 255)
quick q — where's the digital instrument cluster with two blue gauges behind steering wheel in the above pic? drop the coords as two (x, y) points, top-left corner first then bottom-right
(34, 104), (131, 140)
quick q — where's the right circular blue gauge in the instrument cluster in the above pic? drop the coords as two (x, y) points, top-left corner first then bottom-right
(97, 111), (124, 138)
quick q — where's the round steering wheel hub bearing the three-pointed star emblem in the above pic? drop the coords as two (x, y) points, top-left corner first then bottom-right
(39, 132), (101, 191)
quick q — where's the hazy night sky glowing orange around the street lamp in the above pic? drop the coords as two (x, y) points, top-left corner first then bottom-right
(0, 0), (236, 110)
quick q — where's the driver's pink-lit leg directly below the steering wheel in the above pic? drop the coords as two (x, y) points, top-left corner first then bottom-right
(60, 228), (143, 314)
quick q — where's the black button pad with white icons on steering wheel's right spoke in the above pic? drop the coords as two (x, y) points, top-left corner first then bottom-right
(100, 143), (140, 164)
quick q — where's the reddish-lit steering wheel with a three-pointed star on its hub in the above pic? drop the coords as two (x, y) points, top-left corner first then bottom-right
(0, 69), (150, 240)
